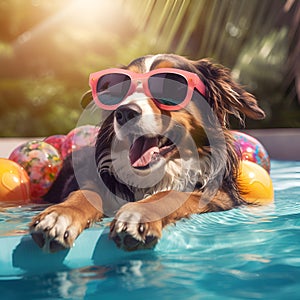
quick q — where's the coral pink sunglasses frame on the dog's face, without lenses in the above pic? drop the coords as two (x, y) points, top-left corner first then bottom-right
(89, 68), (206, 111)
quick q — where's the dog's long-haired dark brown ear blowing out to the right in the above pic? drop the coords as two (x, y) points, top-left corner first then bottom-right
(193, 59), (265, 125)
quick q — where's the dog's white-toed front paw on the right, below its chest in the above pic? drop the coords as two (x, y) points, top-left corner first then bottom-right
(110, 203), (162, 251)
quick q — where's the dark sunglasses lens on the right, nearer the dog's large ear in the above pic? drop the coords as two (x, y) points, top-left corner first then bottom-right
(148, 73), (188, 106)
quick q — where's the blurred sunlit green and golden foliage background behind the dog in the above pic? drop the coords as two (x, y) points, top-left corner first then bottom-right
(0, 0), (300, 137)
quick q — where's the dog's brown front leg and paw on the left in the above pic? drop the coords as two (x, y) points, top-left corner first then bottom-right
(29, 190), (103, 252)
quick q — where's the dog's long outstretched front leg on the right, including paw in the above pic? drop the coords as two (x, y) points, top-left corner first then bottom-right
(110, 191), (234, 251)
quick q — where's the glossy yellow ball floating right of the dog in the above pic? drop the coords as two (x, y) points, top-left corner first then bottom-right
(237, 160), (274, 205)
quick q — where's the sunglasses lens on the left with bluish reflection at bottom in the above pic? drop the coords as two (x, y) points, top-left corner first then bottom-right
(96, 73), (131, 105)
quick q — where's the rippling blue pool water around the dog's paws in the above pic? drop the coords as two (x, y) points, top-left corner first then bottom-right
(0, 161), (300, 299)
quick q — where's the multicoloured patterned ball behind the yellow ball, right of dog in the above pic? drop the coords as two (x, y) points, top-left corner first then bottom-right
(232, 131), (271, 173)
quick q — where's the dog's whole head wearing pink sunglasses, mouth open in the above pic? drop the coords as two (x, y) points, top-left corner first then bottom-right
(90, 54), (264, 202)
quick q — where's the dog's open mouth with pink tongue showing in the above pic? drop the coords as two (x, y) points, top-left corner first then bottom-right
(129, 136), (176, 169)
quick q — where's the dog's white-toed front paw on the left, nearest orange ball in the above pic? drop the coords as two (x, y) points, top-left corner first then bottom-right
(29, 205), (84, 252)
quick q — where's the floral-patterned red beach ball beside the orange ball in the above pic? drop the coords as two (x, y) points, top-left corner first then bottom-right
(9, 141), (62, 200)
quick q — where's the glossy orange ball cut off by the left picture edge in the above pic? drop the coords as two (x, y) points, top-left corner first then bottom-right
(0, 158), (30, 204)
